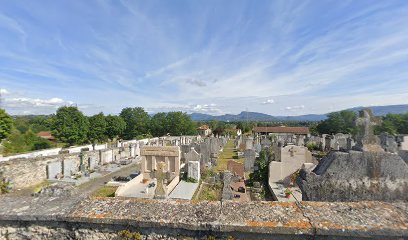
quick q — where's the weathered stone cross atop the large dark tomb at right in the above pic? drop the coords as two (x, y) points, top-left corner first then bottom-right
(355, 108), (383, 152)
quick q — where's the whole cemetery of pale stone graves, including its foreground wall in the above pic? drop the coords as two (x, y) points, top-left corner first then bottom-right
(0, 110), (408, 239)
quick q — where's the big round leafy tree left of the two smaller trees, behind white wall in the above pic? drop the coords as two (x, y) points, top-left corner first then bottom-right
(52, 106), (89, 145)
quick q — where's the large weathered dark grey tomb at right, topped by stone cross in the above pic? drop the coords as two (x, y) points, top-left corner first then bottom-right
(298, 110), (408, 201)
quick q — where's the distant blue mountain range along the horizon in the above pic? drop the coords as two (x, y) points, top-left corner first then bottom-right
(190, 104), (408, 122)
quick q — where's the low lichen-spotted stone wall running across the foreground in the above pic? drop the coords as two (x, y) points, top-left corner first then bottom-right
(0, 198), (408, 239)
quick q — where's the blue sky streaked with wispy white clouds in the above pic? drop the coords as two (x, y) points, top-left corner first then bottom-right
(0, 0), (408, 115)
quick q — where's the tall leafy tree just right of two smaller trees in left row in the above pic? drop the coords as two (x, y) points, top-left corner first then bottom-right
(120, 107), (150, 139)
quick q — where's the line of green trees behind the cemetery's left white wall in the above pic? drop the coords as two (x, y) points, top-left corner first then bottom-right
(0, 106), (197, 154)
